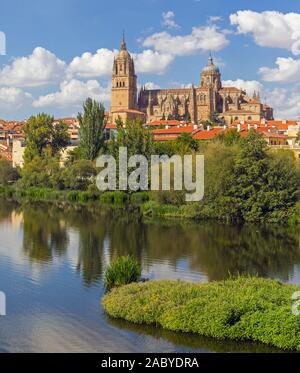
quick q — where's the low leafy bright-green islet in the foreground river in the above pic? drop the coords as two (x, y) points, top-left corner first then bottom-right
(102, 277), (300, 351)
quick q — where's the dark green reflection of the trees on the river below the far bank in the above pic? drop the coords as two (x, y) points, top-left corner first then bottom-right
(0, 204), (300, 286)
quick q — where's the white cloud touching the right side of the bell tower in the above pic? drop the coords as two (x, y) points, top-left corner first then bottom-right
(132, 49), (174, 74)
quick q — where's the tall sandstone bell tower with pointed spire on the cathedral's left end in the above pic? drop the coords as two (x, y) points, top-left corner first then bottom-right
(110, 33), (137, 113)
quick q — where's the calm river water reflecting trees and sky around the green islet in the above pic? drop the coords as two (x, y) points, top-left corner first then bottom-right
(0, 201), (300, 352)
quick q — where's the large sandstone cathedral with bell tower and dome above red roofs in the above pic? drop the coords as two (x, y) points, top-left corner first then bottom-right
(110, 35), (273, 124)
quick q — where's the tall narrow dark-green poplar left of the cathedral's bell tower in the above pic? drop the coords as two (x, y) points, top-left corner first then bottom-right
(78, 98), (105, 160)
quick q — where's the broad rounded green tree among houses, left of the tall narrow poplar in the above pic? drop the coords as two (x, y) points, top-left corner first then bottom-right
(24, 113), (70, 163)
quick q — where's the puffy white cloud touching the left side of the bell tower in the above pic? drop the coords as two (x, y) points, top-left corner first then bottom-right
(68, 48), (116, 78)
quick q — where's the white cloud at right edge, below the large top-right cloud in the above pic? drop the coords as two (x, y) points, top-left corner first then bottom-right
(259, 57), (300, 83)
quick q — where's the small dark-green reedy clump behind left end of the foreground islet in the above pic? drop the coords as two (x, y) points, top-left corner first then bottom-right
(104, 256), (141, 289)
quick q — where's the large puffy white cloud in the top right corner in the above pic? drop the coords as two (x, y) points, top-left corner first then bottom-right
(229, 10), (300, 54)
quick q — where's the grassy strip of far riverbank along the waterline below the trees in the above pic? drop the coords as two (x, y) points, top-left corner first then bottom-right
(0, 186), (300, 226)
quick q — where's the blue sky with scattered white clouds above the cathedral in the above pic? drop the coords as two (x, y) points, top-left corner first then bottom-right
(0, 0), (300, 120)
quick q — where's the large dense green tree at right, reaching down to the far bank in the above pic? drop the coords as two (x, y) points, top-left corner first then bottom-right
(228, 131), (299, 221)
